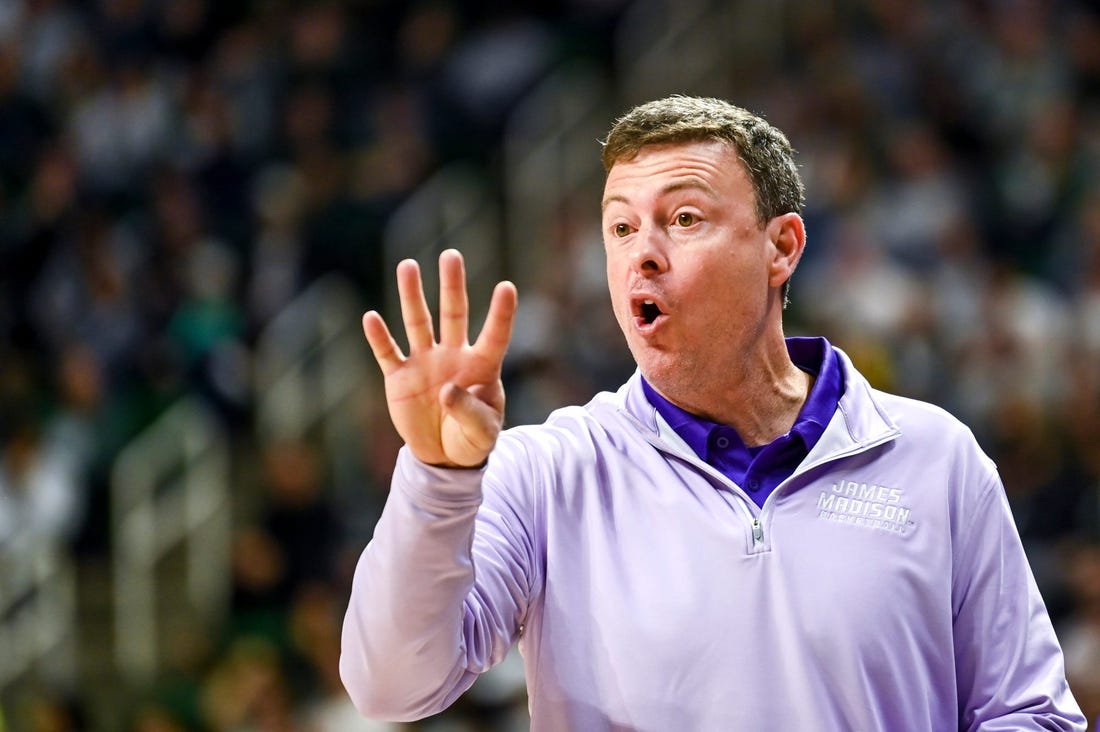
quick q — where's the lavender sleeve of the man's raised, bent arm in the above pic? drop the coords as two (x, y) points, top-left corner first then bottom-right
(340, 445), (534, 721)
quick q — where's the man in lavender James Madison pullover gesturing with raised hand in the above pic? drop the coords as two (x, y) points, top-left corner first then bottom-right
(341, 97), (1085, 732)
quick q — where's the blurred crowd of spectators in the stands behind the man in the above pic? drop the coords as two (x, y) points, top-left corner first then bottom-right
(0, 0), (1100, 732)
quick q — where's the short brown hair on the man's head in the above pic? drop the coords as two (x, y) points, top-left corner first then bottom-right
(603, 95), (805, 225)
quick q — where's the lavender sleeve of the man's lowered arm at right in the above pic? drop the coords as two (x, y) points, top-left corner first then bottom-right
(953, 472), (1086, 732)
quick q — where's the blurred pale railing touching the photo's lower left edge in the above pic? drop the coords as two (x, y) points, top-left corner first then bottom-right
(0, 542), (77, 691)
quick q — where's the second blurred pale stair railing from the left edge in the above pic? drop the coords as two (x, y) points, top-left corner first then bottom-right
(111, 397), (231, 684)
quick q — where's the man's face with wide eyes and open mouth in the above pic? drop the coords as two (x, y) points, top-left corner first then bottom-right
(603, 142), (779, 405)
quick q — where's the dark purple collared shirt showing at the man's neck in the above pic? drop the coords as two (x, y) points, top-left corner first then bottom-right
(641, 338), (844, 506)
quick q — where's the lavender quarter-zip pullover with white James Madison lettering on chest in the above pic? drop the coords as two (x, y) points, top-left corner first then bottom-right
(340, 350), (1086, 732)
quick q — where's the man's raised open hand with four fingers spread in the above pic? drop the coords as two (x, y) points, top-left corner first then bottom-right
(363, 249), (517, 468)
